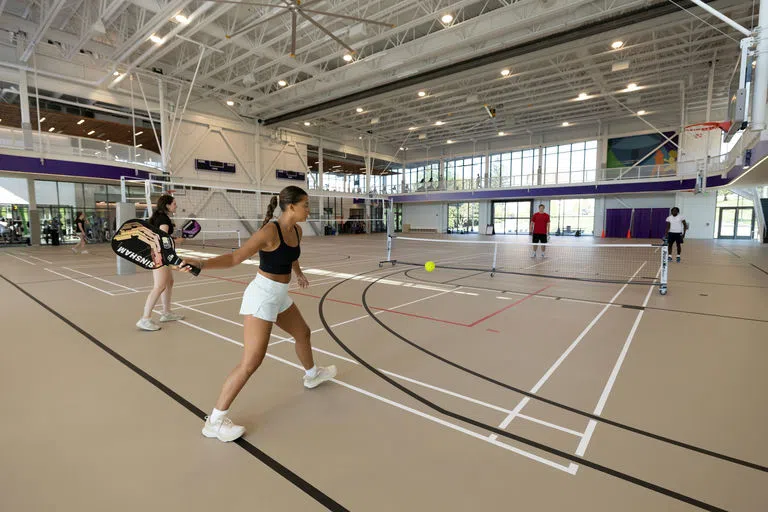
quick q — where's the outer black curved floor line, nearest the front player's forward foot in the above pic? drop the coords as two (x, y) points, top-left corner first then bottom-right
(318, 271), (725, 512)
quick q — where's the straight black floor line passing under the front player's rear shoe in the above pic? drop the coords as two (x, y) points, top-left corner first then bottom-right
(0, 274), (348, 512)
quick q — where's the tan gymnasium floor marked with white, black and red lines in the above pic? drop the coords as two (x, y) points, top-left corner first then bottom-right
(0, 236), (768, 512)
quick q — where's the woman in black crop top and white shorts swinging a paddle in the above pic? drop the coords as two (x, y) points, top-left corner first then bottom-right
(181, 186), (336, 442)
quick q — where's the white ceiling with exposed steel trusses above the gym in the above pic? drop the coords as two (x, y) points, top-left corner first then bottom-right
(0, 0), (757, 148)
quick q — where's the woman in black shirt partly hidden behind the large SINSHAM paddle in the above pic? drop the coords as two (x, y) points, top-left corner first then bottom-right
(136, 194), (184, 331)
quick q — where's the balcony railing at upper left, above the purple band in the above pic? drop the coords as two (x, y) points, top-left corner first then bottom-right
(0, 128), (162, 170)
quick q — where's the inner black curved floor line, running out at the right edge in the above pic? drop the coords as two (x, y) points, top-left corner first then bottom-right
(362, 271), (768, 473)
